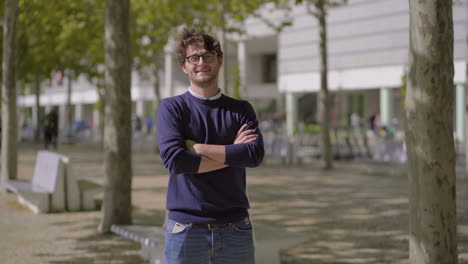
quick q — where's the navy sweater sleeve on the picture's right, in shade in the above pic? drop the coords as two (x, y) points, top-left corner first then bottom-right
(225, 103), (265, 168)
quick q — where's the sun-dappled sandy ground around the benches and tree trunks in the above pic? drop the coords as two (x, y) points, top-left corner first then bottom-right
(0, 145), (468, 264)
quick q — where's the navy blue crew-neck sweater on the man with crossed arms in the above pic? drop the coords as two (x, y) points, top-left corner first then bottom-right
(157, 92), (264, 224)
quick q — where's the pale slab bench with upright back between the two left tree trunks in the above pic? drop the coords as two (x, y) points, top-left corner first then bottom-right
(2, 151), (102, 213)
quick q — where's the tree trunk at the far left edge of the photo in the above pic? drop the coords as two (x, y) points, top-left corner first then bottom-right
(1, 0), (18, 188)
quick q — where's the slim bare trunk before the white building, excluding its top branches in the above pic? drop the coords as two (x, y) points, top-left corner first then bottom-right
(316, 0), (333, 169)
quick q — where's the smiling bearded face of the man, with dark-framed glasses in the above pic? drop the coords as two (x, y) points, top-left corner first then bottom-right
(182, 45), (223, 85)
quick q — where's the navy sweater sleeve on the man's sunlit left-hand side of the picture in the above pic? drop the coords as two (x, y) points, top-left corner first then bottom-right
(157, 100), (201, 174)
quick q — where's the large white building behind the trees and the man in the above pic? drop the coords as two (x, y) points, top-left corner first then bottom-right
(18, 0), (468, 140)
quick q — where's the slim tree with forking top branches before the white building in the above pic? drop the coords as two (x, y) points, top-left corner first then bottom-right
(296, 0), (348, 169)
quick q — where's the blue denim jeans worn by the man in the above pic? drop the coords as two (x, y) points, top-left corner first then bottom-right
(164, 217), (255, 264)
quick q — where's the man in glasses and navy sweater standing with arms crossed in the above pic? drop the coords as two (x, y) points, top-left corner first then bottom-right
(157, 28), (264, 264)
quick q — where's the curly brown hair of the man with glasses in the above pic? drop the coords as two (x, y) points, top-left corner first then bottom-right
(177, 26), (223, 64)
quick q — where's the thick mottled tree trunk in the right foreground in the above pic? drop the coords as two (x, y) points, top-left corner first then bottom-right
(405, 0), (458, 264)
